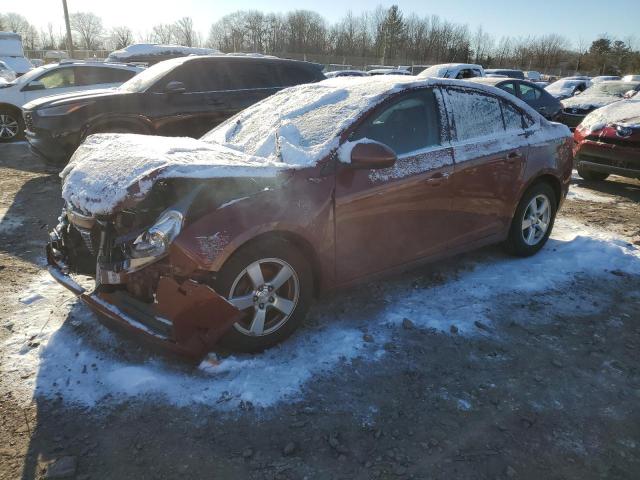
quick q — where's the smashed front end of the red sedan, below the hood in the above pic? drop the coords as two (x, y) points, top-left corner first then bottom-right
(47, 179), (272, 360)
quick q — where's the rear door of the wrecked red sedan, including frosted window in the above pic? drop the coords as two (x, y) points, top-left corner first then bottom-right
(444, 87), (528, 244)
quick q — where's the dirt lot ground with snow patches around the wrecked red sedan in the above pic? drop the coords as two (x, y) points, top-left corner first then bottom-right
(0, 144), (640, 480)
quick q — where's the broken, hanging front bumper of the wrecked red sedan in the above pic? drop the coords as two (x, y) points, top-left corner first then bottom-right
(46, 241), (242, 361)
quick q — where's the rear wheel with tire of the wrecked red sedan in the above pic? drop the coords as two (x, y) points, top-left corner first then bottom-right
(506, 183), (558, 257)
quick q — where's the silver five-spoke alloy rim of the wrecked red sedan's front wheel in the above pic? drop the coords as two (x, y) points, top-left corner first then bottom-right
(228, 258), (300, 337)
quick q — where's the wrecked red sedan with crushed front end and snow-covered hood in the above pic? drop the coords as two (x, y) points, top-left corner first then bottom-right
(47, 76), (572, 358)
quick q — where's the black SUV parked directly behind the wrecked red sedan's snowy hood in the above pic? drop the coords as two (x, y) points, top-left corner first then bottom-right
(23, 55), (325, 163)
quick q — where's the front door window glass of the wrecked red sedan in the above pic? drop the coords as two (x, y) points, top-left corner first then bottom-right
(351, 90), (441, 155)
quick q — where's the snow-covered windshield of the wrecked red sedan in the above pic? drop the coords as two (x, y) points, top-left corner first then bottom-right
(202, 76), (424, 165)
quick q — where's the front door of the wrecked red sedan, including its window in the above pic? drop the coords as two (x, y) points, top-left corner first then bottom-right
(335, 89), (453, 283)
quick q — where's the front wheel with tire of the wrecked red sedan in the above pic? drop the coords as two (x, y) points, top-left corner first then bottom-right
(215, 238), (313, 352)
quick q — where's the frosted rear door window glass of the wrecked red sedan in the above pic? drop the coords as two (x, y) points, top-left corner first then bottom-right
(444, 88), (504, 141)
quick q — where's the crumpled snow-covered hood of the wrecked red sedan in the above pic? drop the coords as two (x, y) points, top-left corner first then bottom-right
(60, 134), (290, 216)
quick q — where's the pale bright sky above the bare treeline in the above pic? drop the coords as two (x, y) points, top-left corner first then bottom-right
(2, 0), (640, 48)
